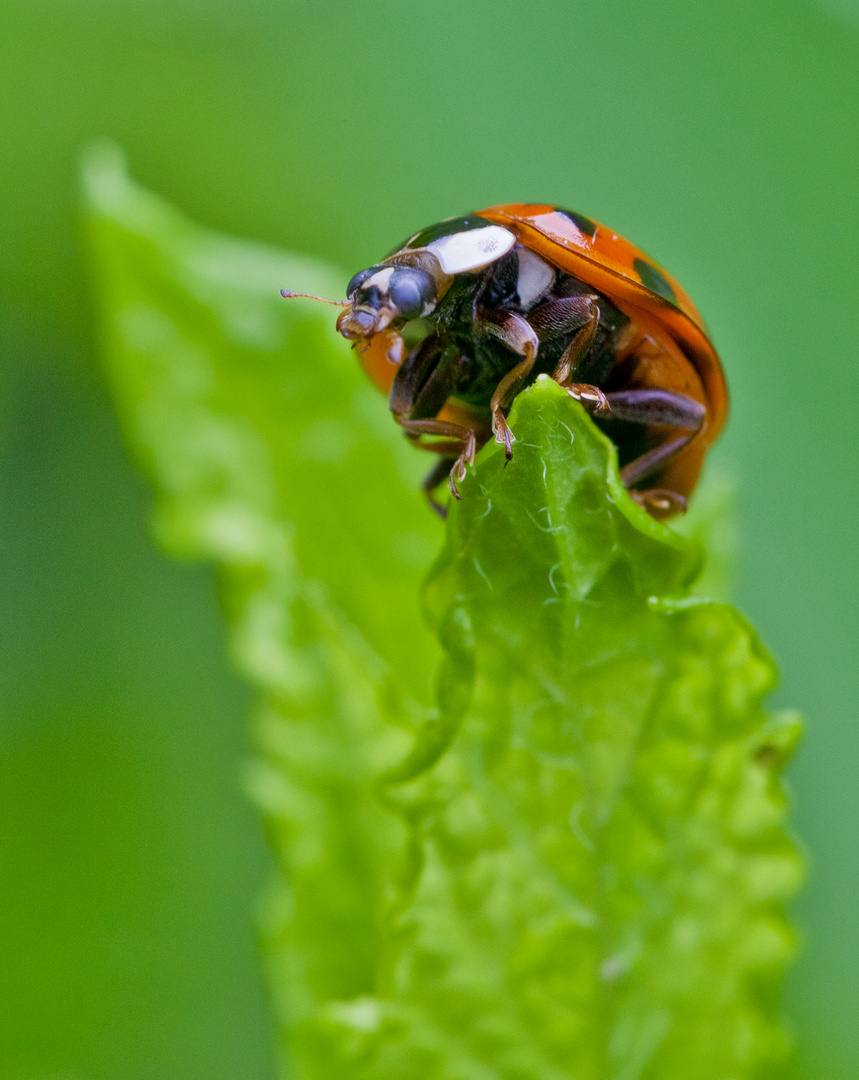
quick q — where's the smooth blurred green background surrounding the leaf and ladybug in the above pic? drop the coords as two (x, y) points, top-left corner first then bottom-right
(0, 0), (859, 1080)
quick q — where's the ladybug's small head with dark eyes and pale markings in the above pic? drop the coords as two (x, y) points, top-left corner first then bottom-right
(337, 262), (437, 340)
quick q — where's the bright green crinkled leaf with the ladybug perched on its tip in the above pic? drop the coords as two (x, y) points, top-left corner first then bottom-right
(86, 151), (802, 1080)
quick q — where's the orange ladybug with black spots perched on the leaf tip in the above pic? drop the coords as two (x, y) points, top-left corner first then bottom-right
(283, 203), (727, 518)
